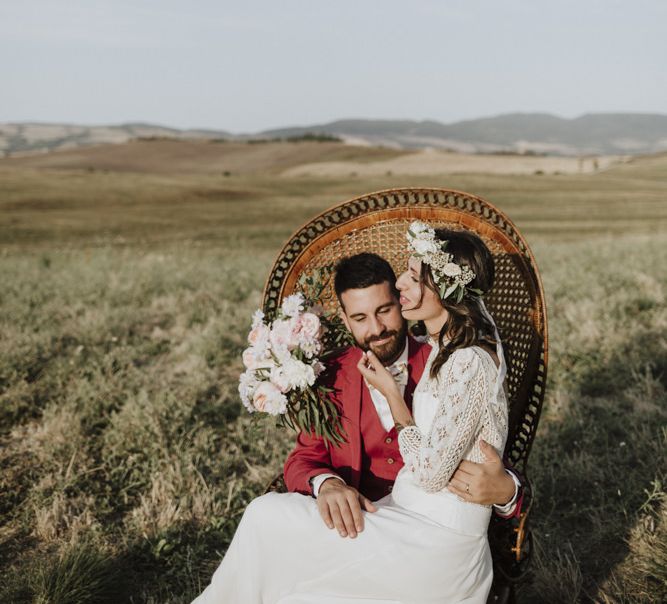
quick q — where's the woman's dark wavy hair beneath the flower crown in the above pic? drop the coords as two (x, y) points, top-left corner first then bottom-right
(413, 229), (496, 378)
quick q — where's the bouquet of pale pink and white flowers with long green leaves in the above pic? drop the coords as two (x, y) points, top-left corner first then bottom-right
(239, 293), (343, 444)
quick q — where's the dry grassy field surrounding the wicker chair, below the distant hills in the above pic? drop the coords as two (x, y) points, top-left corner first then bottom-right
(0, 143), (667, 603)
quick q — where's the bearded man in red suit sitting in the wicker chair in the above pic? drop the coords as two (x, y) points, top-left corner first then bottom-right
(285, 253), (521, 538)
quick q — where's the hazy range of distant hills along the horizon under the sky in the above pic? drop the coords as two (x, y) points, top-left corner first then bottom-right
(0, 113), (667, 156)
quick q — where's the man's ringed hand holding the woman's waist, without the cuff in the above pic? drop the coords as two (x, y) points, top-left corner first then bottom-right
(447, 440), (516, 505)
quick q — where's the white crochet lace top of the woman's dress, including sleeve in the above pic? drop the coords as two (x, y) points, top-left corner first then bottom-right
(398, 346), (507, 493)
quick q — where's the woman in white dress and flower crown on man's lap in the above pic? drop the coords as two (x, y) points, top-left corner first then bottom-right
(195, 222), (507, 604)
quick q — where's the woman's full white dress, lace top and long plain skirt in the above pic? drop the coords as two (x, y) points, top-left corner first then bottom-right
(195, 347), (507, 604)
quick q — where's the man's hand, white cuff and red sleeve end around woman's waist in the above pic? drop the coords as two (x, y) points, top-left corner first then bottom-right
(447, 440), (523, 518)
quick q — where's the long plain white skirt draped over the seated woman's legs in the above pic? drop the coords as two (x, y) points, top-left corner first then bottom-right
(193, 493), (493, 604)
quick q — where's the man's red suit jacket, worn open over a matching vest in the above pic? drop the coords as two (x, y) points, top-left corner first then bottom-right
(284, 336), (523, 517)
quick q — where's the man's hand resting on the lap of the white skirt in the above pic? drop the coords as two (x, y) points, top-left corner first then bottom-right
(317, 478), (377, 539)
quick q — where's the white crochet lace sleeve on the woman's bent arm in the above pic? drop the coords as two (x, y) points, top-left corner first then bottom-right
(398, 348), (491, 493)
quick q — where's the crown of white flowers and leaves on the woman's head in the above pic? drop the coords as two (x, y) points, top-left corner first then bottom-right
(406, 220), (482, 302)
